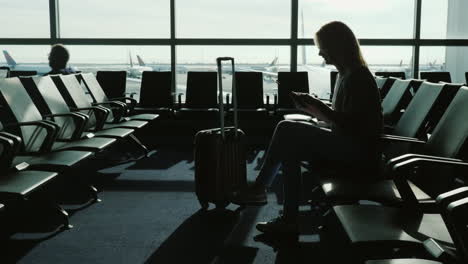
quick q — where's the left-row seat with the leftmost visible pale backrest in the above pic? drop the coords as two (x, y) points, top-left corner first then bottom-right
(0, 78), (115, 153)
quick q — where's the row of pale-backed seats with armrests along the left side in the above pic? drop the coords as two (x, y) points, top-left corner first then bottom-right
(0, 74), (158, 233)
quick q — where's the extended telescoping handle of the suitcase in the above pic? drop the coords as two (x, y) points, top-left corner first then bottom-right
(216, 57), (238, 139)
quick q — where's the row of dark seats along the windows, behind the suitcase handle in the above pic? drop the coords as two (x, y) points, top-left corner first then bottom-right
(97, 71), (309, 120)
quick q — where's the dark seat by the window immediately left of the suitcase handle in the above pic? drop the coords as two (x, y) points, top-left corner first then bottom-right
(176, 71), (219, 121)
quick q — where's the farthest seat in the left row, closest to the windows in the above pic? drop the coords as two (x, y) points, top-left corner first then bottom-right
(76, 73), (158, 121)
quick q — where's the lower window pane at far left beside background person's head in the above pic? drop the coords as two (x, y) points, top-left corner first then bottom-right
(0, 45), (50, 75)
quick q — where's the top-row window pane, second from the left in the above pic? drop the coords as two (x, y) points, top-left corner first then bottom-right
(60, 0), (170, 38)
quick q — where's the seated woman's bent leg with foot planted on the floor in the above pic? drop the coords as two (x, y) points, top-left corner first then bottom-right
(257, 122), (370, 233)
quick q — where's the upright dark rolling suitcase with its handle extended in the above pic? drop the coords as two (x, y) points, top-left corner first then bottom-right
(194, 57), (247, 209)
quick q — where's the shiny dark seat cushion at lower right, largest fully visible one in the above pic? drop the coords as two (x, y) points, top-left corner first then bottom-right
(333, 205), (453, 248)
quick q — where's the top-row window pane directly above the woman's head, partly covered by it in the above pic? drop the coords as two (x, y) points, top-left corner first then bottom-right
(298, 0), (414, 38)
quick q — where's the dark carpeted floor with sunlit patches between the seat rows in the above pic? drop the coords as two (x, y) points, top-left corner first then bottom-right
(0, 148), (354, 264)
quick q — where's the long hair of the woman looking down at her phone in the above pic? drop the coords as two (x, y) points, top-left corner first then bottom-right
(315, 21), (367, 66)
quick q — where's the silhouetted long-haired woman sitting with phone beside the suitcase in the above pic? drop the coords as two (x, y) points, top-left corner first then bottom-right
(234, 21), (382, 235)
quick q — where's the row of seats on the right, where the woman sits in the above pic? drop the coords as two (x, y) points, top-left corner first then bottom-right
(313, 77), (468, 264)
